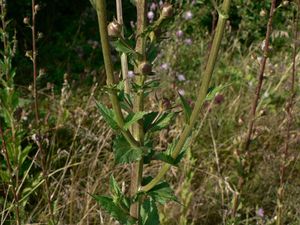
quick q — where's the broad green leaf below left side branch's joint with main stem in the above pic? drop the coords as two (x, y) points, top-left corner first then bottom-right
(113, 135), (143, 164)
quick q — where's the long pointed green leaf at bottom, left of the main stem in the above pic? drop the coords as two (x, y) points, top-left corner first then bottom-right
(92, 195), (136, 225)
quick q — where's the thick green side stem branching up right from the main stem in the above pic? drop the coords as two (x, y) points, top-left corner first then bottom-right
(141, 0), (230, 192)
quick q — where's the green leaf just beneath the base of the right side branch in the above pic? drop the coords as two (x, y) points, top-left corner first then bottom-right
(147, 182), (178, 204)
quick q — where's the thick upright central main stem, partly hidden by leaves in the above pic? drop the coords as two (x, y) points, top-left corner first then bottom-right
(130, 0), (147, 221)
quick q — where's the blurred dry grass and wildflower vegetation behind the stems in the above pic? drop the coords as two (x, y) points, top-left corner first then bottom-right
(0, 0), (300, 225)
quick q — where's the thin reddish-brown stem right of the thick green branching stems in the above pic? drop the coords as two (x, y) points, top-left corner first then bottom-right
(232, 0), (276, 218)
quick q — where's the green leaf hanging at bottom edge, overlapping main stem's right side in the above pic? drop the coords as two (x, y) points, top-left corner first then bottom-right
(141, 198), (160, 225)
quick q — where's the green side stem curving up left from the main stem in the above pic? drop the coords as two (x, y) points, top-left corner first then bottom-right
(96, 0), (140, 147)
